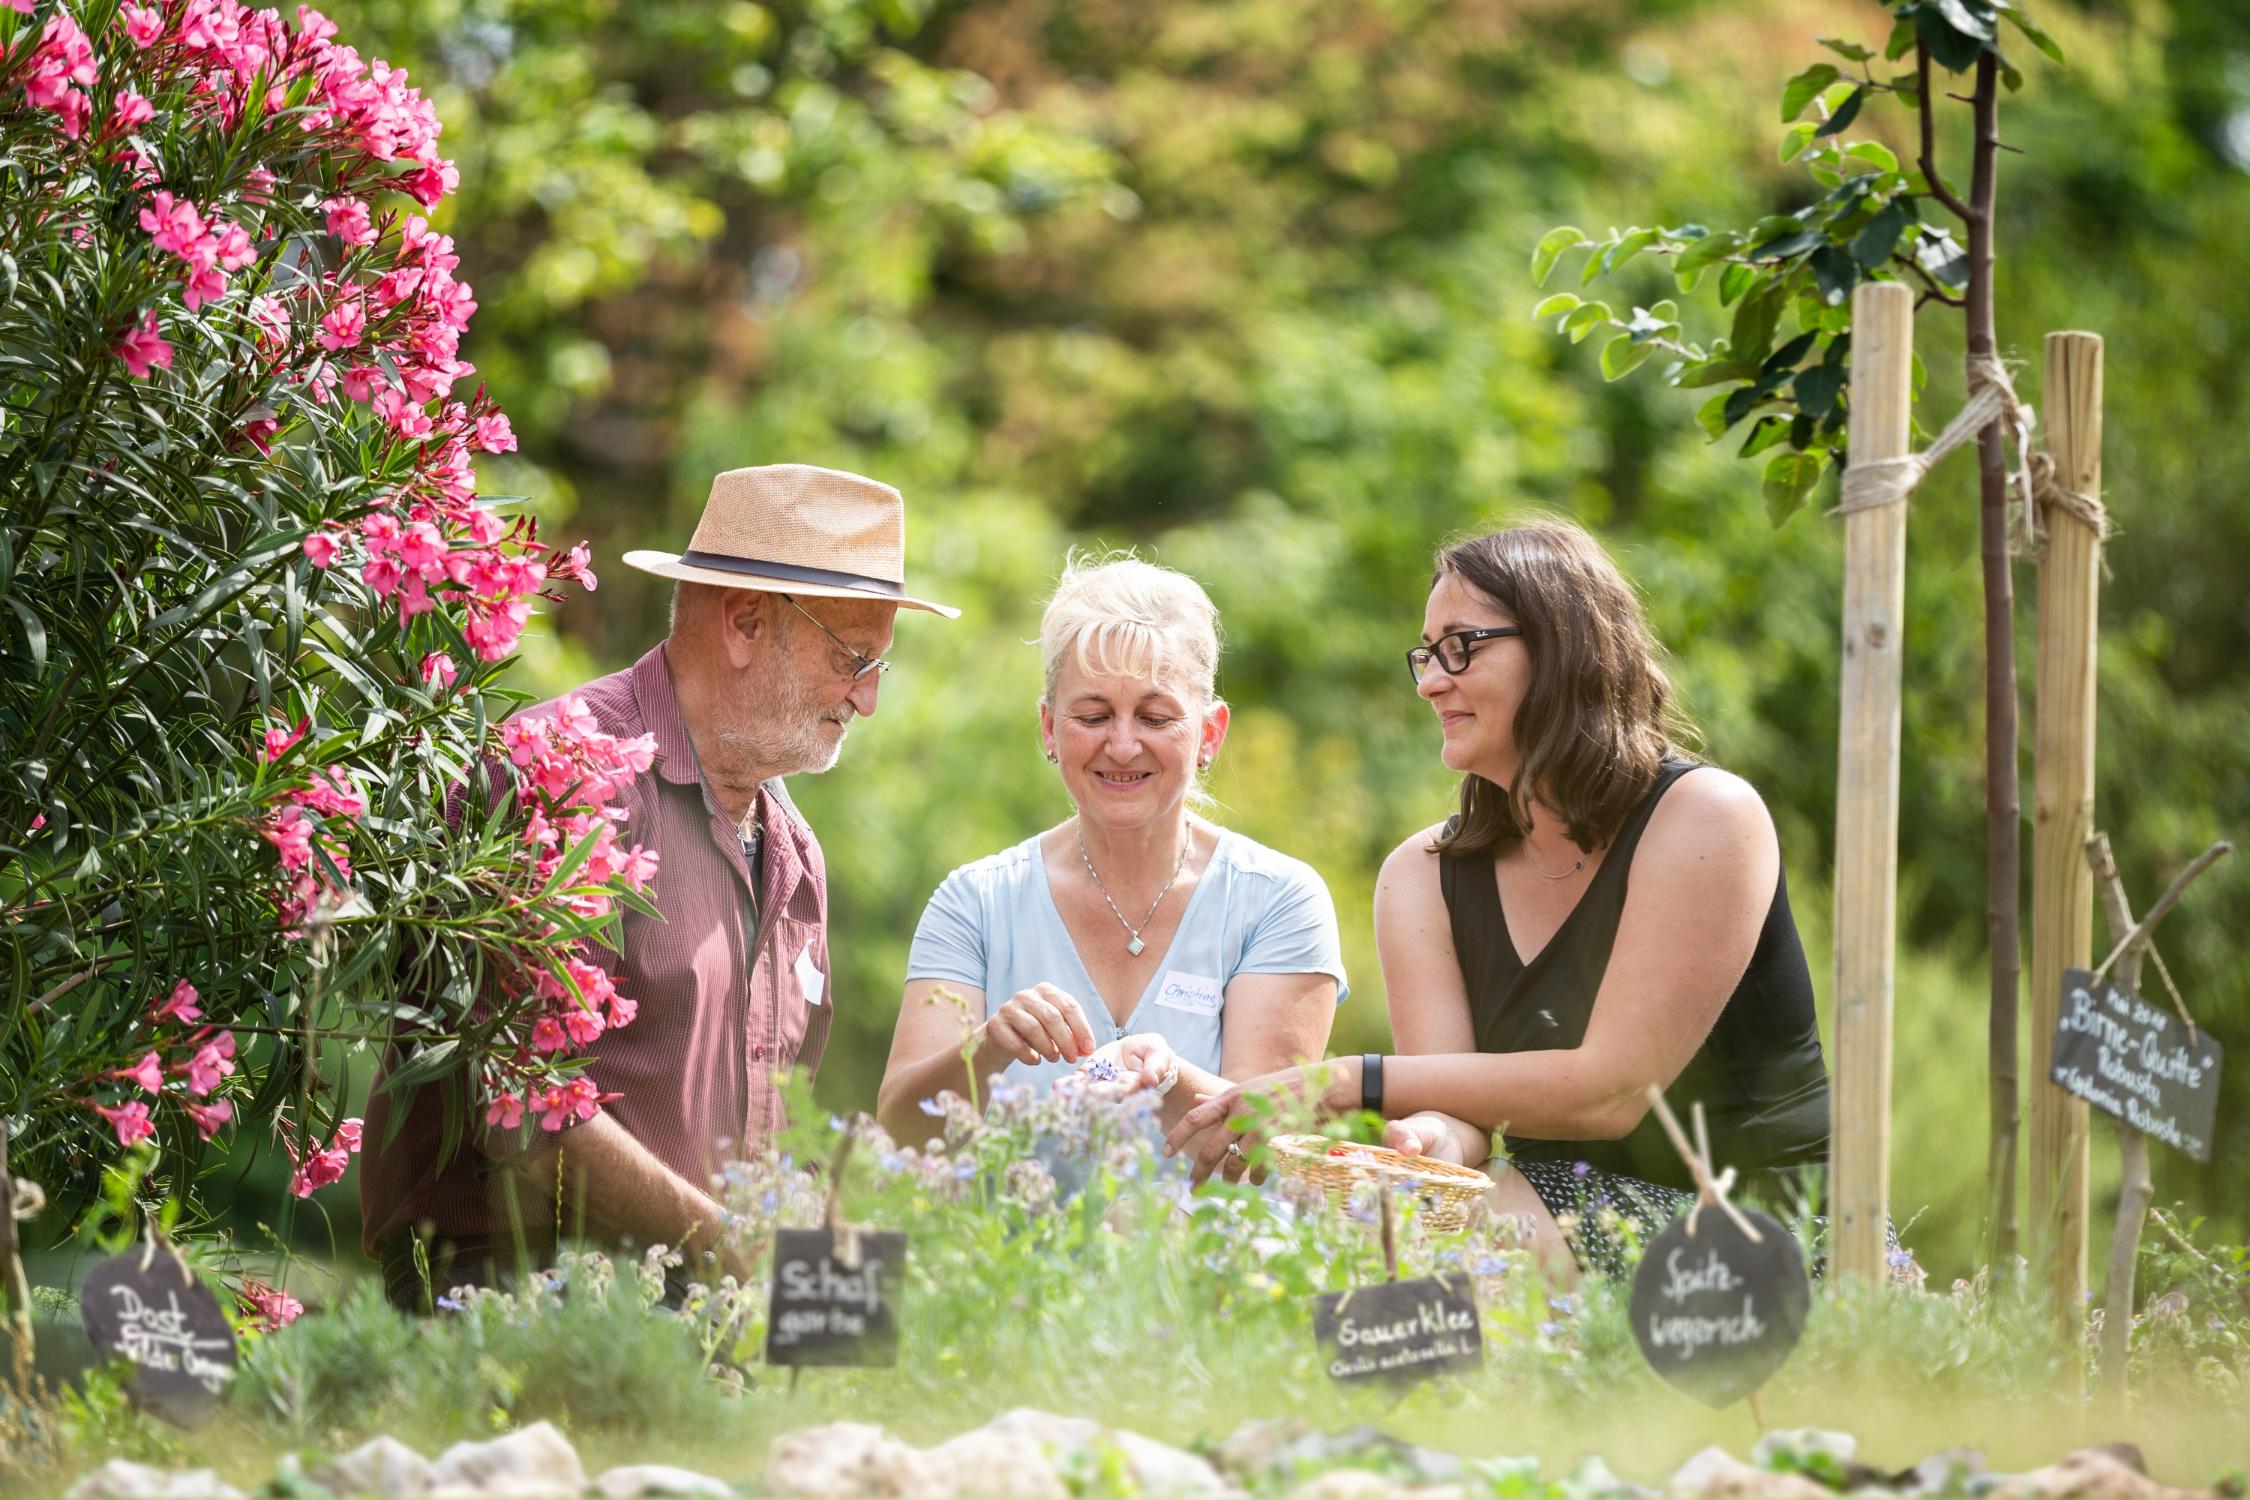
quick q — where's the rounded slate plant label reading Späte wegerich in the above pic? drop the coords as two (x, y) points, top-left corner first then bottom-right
(1631, 1208), (1814, 1406)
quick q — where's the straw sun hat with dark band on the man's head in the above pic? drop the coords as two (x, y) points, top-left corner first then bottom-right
(626, 463), (961, 618)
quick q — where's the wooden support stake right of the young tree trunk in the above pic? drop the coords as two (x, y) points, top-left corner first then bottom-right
(2025, 333), (2102, 1322)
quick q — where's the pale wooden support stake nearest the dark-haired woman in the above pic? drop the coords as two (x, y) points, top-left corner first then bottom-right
(1832, 281), (1915, 1284)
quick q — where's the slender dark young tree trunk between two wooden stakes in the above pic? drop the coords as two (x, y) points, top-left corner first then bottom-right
(1964, 52), (2023, 1259)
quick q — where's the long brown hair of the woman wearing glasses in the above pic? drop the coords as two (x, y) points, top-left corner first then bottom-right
(1431, 519), (1694, 855)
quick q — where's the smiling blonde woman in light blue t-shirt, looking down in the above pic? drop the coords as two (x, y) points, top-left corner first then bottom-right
(878, 558), (1348, 1176)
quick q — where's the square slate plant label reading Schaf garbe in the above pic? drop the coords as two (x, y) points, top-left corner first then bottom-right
(765, 1230), (907, 1365)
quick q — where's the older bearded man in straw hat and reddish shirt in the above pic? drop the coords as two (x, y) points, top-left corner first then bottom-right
(360, 463), (959, 1309)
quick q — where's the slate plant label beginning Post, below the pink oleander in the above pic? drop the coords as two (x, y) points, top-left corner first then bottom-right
(79, 1246), (234, 1428)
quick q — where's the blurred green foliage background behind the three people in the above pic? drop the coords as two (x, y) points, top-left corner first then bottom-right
(299, 0), (2250, 1273)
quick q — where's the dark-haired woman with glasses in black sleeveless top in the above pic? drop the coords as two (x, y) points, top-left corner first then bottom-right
(1170, 522), (1829, 1271)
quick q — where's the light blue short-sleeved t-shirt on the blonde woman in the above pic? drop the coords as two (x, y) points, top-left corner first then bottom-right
(907, 830), (1350, 1088)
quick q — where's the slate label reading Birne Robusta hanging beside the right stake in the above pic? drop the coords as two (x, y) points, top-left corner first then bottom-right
(2048, 969), (2225, 1160)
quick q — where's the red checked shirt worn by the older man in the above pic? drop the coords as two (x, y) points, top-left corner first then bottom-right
(360, 645), (830, 1255)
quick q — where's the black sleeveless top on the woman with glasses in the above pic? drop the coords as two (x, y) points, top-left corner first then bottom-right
(1438, 760), (1829, 1190)
